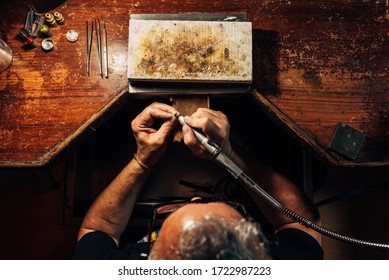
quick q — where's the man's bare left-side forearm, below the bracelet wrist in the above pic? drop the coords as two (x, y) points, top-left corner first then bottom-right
(78, 160), (150, 244)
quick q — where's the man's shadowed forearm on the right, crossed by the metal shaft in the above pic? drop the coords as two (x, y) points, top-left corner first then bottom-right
(227, 149), (319, 229)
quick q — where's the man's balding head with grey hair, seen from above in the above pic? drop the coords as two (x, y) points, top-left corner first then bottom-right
(150, 202), (264, 259)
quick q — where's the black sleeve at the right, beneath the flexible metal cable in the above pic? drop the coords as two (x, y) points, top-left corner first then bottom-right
(268, 228), (324, 260)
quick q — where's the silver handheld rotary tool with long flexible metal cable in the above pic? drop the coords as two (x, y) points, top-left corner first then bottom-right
(174, 113), (389, 250)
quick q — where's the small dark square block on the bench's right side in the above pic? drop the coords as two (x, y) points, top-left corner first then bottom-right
(329, 123), (366, 160)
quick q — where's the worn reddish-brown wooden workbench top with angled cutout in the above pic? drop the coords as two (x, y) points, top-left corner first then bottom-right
(0, 0), (389, 166)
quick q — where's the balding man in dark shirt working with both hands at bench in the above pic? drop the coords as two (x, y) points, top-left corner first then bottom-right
(74, 103), (323, 259)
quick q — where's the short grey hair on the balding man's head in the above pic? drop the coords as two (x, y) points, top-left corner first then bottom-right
(176, 216), (267, 260)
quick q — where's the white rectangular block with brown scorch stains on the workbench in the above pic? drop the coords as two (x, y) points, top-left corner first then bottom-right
(127, 18), (252, 84)
